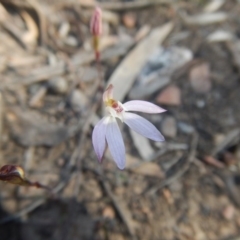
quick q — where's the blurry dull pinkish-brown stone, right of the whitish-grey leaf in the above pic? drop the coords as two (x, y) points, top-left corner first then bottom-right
(189, 63), (212, 93)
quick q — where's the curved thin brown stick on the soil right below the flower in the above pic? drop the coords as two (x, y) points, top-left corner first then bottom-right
(147, 132), (198, 195)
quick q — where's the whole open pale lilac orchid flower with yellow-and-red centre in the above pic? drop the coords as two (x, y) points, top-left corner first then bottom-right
(92, 85), (166, 169)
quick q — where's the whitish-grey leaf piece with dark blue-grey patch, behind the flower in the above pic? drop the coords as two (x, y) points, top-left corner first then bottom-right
(128, 46), (193, 99)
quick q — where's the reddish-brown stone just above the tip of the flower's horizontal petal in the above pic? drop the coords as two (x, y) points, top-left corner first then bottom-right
(156, 85), (181, 106)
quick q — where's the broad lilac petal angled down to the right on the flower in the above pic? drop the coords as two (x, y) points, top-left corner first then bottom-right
(123, 112), (164, 142)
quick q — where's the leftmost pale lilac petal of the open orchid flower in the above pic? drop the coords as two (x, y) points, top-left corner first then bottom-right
(92, 117), (109, 162)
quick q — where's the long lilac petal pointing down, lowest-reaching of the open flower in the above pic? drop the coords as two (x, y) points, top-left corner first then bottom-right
(106, 117), (125, 169)
